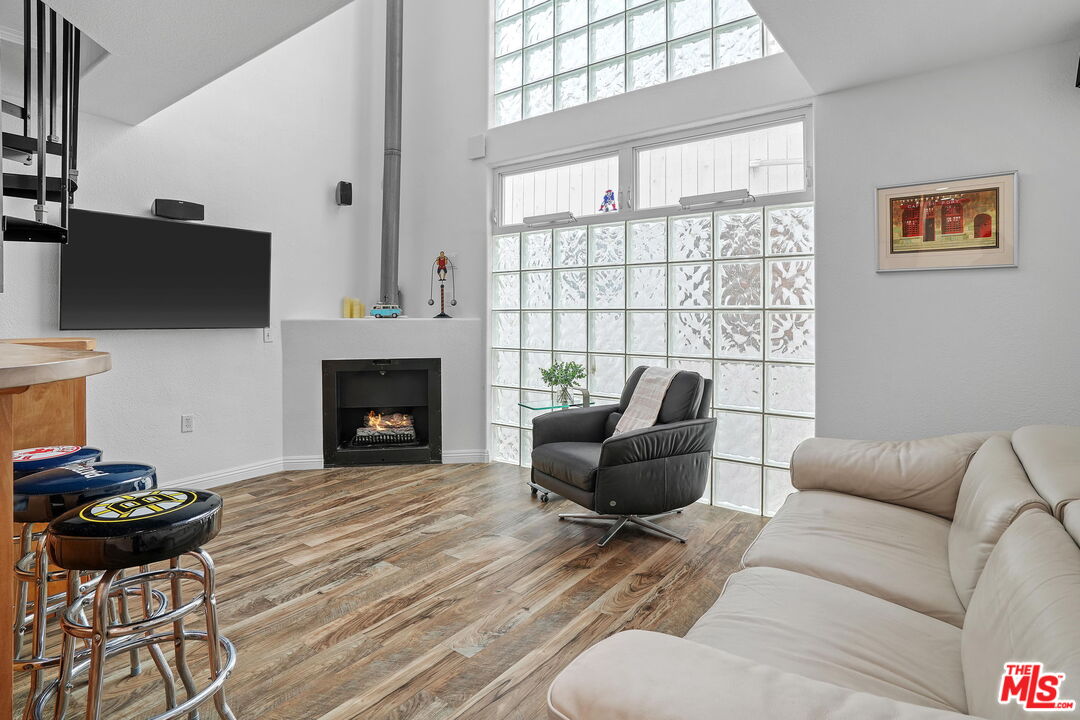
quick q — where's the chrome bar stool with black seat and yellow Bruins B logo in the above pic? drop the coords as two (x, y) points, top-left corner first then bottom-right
(32, 488), (237, 720)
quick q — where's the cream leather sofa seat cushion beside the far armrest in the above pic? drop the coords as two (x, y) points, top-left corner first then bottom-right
(743, 490), (964, 626)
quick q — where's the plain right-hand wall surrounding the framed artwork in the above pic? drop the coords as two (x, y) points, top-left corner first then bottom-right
(814, 42), (1080, 438)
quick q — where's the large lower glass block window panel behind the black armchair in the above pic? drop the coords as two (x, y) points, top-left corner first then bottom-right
(490, 203), (814, 515)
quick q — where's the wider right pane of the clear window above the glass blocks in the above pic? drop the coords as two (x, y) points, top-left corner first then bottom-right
(635, 121), (806, 209)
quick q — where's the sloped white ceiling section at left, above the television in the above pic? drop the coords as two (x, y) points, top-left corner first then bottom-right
(35, 0), (351, 124)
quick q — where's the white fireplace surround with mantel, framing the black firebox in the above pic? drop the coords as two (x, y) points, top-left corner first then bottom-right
(281, 317), (487, 470)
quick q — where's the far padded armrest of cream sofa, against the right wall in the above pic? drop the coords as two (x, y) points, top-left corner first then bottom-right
(792, 433), (995, 519)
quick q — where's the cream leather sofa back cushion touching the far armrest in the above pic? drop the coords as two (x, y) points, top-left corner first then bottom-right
(948, 435), (1050, 607)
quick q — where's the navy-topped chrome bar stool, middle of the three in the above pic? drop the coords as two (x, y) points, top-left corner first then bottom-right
(13, 462), (157, 717)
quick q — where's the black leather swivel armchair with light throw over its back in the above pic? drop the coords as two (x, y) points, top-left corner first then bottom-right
(532, 367), (716, 546)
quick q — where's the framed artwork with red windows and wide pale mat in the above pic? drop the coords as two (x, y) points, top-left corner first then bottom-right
(877, 173), (1016, 272)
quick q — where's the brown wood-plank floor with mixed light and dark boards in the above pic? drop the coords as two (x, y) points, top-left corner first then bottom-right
(16, 464), (764, 720)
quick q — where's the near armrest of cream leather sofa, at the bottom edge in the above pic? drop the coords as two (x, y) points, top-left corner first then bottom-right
(548, 630), (971, 720)
